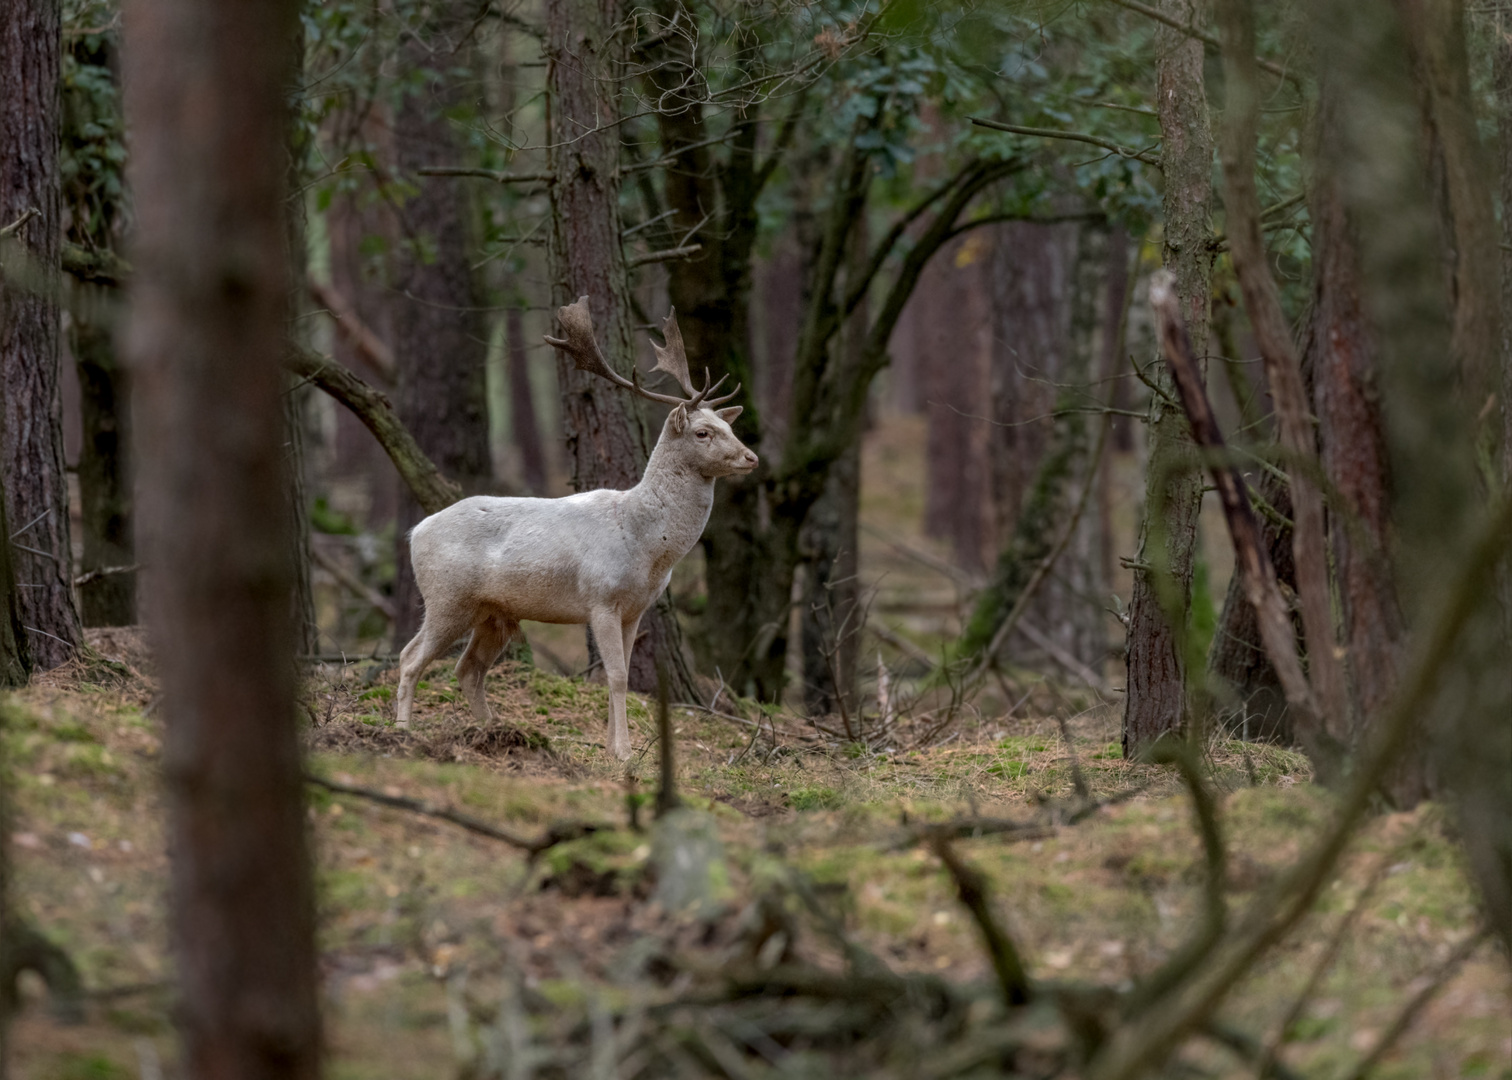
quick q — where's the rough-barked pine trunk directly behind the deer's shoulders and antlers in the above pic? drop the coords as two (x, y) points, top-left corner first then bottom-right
(546, 0), (695, 700)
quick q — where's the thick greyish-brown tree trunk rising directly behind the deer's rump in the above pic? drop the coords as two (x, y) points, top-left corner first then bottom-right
(392, 8), (493, 647)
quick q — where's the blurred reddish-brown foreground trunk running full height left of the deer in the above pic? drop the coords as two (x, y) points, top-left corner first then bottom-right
(122, 0), (321, 1080)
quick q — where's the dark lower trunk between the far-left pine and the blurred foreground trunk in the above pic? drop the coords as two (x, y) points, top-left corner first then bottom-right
(70, 297), (136, 626)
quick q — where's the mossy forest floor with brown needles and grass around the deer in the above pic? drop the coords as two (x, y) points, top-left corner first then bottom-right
(6, 634), (1512, 1080)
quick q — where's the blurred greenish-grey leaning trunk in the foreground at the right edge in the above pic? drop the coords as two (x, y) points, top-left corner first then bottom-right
(1315, 0), (1512, 944)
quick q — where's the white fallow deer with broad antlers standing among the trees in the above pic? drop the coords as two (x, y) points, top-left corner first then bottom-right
(398, 296), (756, 761)
